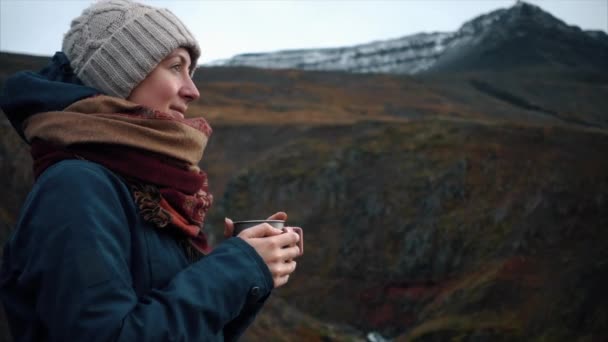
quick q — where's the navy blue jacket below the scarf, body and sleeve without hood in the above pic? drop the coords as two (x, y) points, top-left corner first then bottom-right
(0, 160), (273, 342)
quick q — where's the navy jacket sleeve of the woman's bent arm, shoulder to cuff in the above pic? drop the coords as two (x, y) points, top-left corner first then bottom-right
(7, 162), (272, 341)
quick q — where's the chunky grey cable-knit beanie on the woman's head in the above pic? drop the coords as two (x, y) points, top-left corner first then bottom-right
(62, 0), (201, 98)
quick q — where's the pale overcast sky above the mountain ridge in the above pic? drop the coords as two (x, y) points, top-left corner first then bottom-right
(0, 0), (608, 64)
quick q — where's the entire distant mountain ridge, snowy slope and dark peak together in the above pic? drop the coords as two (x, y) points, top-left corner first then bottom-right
(214, 1), (608, 74)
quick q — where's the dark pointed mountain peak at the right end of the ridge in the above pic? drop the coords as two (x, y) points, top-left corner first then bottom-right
(432, 2), (608, 71)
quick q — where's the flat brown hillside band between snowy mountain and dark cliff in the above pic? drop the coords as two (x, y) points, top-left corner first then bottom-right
(192, 68), (608, 128)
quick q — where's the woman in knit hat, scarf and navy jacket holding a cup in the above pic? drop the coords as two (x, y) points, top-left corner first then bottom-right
(0, 0), (300, 341)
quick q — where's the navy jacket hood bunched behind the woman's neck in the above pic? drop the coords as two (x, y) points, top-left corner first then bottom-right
(0, 52), (102, 140)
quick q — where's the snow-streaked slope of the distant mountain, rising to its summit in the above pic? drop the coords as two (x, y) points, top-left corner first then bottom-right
(209, 1), (606, 74)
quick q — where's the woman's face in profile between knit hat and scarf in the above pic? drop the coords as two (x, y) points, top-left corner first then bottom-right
(127, 48), (200, 118)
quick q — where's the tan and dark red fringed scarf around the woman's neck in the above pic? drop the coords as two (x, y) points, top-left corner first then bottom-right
(24, 96), (213, 260)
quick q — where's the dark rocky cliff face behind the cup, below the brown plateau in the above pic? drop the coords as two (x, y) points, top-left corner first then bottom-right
(215, 119), (608, 341)
